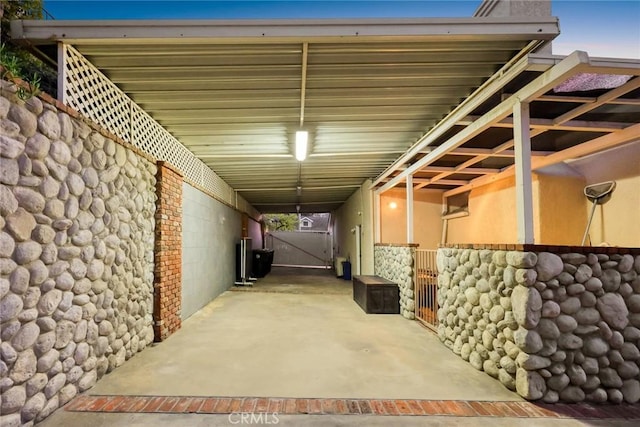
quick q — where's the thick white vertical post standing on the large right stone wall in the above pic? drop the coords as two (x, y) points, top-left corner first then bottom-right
(513, 102), (534, 244)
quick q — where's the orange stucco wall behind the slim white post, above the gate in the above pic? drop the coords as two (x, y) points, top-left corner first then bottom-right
(380, 189), (442, 249)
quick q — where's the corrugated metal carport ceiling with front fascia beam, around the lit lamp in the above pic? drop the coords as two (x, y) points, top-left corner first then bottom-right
(13, 17), (559, 212)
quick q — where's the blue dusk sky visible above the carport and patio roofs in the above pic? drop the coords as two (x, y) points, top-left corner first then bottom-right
(44, 0), (640, 59)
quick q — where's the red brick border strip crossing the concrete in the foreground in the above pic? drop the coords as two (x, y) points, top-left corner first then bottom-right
(64, 395), (640, 420)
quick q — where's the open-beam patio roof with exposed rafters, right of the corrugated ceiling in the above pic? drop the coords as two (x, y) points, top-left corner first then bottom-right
(373, 51), (640, 197)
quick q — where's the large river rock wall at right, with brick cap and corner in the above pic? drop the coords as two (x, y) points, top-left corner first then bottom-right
(437, 248), (640, 403)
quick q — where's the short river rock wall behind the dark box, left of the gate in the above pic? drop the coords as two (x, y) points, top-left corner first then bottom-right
(374, 245), (416, 320)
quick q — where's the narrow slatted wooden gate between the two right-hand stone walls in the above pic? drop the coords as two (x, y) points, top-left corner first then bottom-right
(415, 249), (438, 330)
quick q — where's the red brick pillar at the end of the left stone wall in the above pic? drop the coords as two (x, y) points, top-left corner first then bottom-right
(153, 161), (182, 342)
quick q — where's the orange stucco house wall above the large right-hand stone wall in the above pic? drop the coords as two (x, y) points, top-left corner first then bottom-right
(447, 141), (640, 247)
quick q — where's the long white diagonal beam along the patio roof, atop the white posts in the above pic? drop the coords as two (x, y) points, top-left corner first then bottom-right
(380, 51), (589, 191)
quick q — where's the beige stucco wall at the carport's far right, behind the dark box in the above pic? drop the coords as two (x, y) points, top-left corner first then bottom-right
(333, 180), (373, 274)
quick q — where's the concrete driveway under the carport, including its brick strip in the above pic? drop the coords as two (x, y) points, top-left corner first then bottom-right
(42, 269), (640, 427)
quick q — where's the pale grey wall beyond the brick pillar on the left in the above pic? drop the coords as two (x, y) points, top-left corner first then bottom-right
(182, 183), (242, 320)
